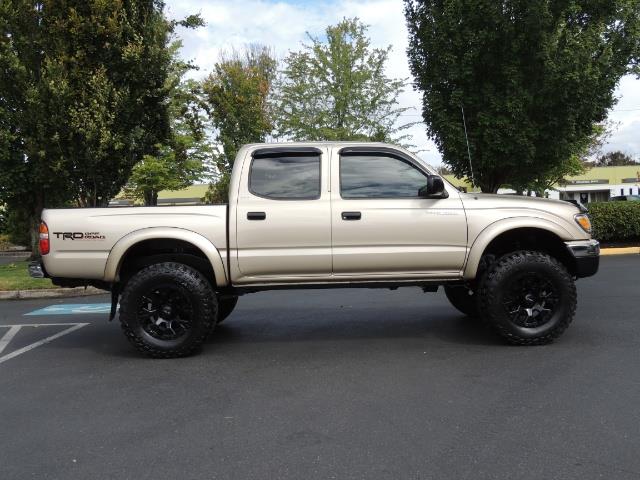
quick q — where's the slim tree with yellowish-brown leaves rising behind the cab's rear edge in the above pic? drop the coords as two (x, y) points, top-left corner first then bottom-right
(203, 45), (277, 203)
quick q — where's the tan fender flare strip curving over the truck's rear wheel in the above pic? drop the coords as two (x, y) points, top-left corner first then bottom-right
(104, 227), (227, 287)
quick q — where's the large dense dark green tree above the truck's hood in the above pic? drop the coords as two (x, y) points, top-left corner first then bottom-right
(405, 0), (640, 192)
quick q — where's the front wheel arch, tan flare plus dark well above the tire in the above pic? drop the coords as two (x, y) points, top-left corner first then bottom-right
(463, 217), (575, 280)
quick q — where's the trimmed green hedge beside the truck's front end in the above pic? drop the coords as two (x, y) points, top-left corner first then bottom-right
(589, 202), (640, 242)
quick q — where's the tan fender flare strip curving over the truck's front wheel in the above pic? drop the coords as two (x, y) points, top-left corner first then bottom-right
(462, 217), (572, 280)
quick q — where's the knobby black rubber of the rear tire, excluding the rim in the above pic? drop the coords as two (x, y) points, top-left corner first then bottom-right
(119, 262), (217, 358)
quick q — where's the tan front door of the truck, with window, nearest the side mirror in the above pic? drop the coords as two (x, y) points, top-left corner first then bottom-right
(331, 147), (467, 278)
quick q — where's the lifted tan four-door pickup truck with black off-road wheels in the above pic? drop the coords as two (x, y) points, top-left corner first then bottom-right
(30, 142), (600, 358)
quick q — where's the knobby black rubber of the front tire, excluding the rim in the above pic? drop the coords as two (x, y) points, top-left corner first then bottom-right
(477, 250), (577, 345)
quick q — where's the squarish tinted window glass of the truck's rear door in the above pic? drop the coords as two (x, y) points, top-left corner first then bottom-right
(249, 156), (320, 200)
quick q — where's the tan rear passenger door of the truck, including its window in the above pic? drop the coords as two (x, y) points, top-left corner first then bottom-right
(235, 147), (331, 283)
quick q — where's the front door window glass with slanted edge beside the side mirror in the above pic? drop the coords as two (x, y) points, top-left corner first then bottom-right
(340, 155), (427, 198)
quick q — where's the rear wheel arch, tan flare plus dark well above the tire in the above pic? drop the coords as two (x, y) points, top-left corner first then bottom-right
(104, 227), (228, 287)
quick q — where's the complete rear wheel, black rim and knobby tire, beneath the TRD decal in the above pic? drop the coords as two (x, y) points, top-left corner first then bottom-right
(120, 262), (217, 358)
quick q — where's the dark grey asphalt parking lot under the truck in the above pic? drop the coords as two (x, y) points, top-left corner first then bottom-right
(0, 255), (640, 480)
